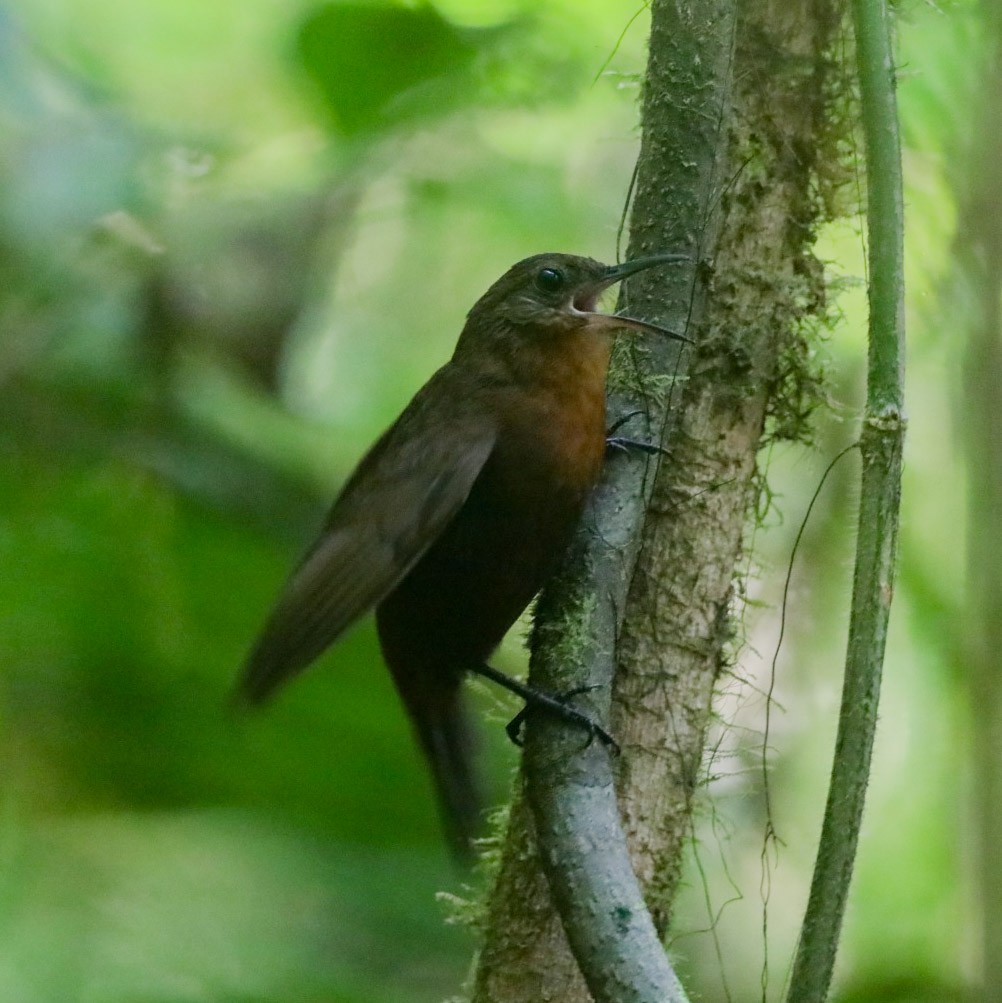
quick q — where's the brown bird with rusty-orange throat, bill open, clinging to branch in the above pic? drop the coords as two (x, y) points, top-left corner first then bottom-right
(241, 254), (688, 854)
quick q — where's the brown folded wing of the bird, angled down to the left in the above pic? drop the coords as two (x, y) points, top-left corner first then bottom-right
(240, 378), (495, 703)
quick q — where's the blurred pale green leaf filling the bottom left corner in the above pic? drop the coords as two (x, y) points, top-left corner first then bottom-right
(0, 810), (468, 1003)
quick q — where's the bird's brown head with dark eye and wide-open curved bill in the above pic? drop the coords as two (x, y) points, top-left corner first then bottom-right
(466, 254), (690, 341)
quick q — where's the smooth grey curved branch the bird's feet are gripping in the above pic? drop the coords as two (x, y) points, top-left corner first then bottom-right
(525, 0), (736, 1003)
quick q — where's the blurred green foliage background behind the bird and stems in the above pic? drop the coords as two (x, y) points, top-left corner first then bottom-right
(0, 0), (982, 1003)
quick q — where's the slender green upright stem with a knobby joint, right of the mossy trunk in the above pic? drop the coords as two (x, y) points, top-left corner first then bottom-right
(787, 0), (905, 1003)
